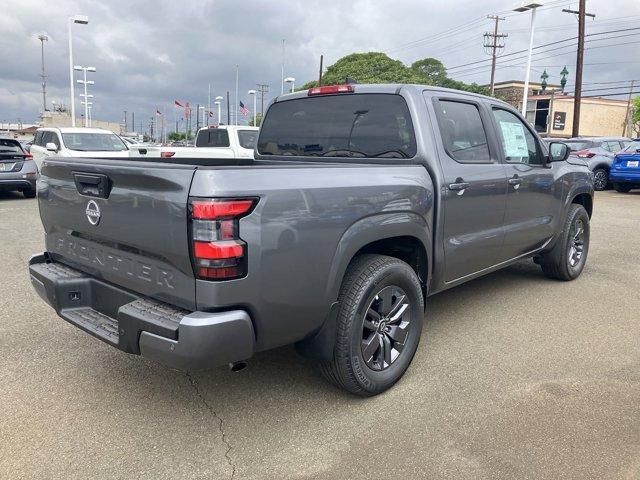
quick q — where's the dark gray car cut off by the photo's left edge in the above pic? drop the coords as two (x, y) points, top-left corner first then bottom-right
(0, 138), (38, 198)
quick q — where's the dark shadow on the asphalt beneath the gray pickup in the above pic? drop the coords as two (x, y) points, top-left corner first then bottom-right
(96, 260), (552, 404)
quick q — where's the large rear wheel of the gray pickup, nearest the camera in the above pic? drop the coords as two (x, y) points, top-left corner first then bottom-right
(317, 255), (424, 397)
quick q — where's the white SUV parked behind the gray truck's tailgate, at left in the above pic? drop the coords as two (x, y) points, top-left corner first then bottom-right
(31, 127), (129, 168)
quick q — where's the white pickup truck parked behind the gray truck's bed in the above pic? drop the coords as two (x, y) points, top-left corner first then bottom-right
(130, 125), (259, 159)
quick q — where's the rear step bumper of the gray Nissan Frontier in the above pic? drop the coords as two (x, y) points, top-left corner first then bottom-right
(29, 253), (255, 370)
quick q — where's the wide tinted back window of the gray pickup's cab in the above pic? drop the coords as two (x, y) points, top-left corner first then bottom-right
(258, 93), (416, 158)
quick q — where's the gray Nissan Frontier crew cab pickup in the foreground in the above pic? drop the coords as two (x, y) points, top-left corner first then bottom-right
(29, 85), (593, 396)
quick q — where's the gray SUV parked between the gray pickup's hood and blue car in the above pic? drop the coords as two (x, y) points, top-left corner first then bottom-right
(563, 137), (631, 190)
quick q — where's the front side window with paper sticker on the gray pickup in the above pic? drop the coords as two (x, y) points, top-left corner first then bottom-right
(492, 108), (543, 165)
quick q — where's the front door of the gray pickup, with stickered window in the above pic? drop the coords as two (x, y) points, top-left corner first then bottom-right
(491, 106), (562, 261)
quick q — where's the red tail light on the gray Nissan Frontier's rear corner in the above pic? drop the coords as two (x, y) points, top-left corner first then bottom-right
(190, 198), (257, 280)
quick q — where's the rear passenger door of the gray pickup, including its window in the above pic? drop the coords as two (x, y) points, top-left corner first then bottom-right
(433, 97), (507, 282)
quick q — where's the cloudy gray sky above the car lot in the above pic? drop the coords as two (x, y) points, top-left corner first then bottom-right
(0, 0), (640, 128)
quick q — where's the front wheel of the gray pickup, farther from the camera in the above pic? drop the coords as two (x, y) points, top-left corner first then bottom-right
(538, 203), (590, 281)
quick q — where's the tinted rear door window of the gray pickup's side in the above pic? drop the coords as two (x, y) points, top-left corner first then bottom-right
(436, 100), (491, 163)
